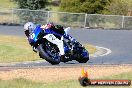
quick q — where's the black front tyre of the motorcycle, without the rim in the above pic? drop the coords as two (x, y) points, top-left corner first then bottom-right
(38, 44), (60, 65)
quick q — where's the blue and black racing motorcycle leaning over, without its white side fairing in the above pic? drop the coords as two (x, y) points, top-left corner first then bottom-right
(30, 27), (89, 65)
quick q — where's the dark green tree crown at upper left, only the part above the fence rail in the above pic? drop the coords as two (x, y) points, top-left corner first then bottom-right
(14, 0), (47, 10)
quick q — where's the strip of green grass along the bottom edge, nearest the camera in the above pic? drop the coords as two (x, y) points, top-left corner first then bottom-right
(0, 72), (132, 88)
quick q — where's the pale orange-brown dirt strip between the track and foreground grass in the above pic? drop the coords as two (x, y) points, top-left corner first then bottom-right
(0, 65), (132, 82)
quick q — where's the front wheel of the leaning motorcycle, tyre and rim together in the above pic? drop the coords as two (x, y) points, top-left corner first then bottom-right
(38, 43), (60, 65)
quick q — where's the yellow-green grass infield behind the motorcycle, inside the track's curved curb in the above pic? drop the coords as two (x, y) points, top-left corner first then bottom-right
(0, 35), (96, 63)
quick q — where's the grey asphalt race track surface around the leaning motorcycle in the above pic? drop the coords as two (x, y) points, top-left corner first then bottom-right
(0, 26), (132, 67)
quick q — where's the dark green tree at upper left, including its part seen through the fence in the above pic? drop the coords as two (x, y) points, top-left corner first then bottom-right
(14, 0), (47, 24)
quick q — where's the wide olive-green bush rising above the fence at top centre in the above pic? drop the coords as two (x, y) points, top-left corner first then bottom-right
(60, 0), (111, 14)
